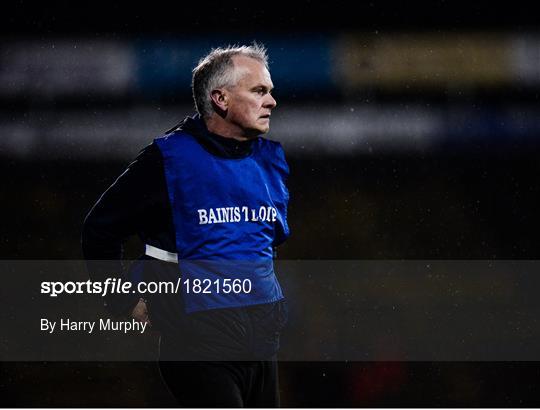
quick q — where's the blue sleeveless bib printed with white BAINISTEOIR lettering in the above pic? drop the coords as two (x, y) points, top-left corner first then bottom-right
(155, 131), (289, 313)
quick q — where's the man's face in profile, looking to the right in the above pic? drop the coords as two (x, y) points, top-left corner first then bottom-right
(225, 56), (276, 138)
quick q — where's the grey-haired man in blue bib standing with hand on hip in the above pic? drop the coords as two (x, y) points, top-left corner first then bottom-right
(82, 44), (289, 407)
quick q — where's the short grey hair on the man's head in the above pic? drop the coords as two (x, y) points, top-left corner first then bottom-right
(191, 43), (268, 118)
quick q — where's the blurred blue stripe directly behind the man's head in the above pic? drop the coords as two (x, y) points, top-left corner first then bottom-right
(134, 34), (335, 96)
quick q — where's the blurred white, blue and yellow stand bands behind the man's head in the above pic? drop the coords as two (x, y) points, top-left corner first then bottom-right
(0, 32), (540, 159)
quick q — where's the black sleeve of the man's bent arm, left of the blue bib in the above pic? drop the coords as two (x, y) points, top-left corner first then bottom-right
(82, 144), (170, 314)
